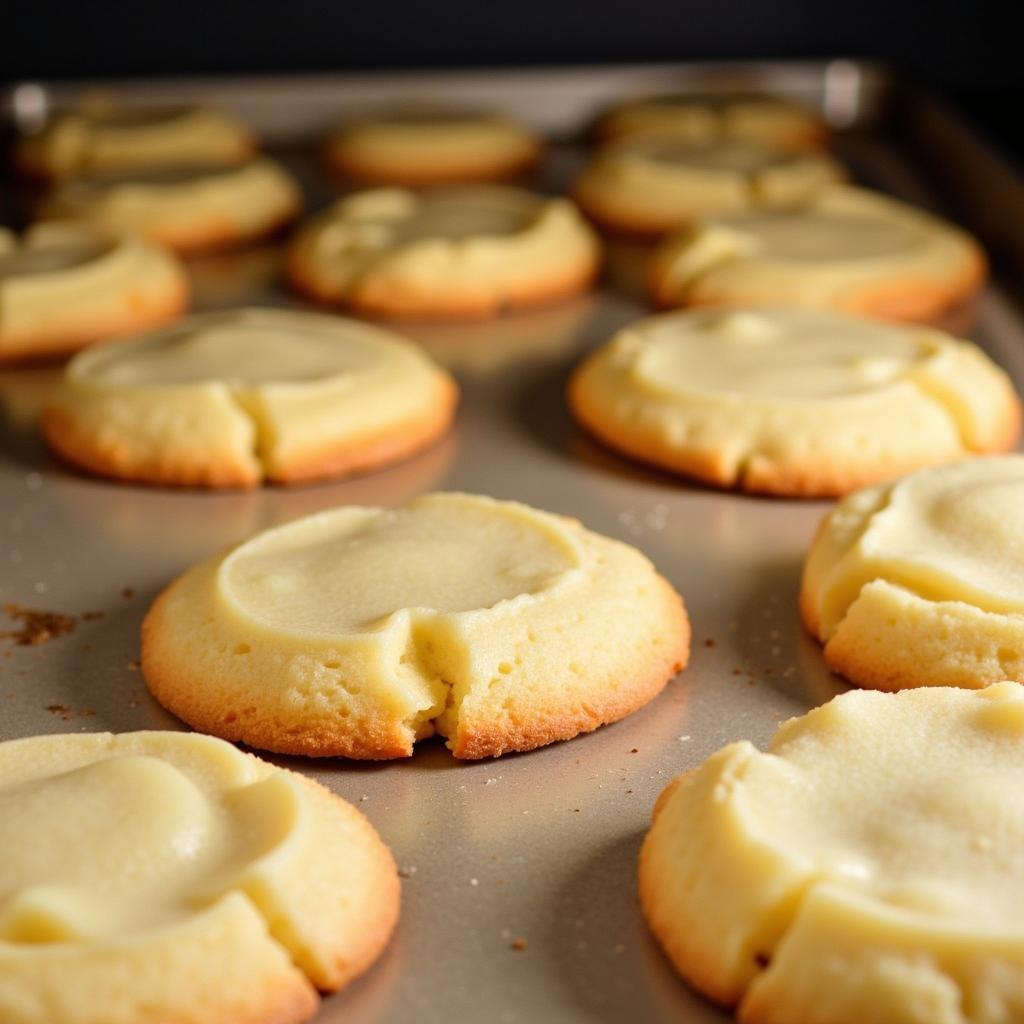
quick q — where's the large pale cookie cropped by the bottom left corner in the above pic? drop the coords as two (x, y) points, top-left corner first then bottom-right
(0, 732), (398, 1024)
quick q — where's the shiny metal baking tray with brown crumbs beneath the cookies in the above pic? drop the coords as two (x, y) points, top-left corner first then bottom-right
(0, 60), (1024, 1024)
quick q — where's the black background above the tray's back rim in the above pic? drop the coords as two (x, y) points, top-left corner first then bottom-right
(6, 0), (1024, 162)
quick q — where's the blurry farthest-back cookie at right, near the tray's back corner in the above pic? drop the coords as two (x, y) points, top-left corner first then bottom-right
(597, 93), (830, 148)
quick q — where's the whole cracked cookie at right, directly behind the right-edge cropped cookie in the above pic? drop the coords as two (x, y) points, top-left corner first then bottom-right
(568, 308), (1021, 496)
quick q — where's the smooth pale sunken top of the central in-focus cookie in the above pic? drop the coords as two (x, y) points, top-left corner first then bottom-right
(219, 495), (585, 636)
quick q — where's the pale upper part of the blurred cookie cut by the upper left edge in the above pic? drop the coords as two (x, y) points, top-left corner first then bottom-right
(0, 222), (187, 343)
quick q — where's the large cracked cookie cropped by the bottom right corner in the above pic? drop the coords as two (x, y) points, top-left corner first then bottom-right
(640, 682), (1024, 1024)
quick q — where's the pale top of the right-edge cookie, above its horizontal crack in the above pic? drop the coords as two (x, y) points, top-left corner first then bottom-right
(804, 455), (1024, 639)
